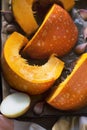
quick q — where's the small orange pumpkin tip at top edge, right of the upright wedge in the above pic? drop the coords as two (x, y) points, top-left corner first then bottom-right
(59, 0), (75, 11)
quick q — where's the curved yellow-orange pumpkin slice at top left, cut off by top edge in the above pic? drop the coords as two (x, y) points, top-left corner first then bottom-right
(12, 0), (38, 35)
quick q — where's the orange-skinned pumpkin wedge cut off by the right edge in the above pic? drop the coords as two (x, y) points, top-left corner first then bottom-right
(47, 53), (87, 110)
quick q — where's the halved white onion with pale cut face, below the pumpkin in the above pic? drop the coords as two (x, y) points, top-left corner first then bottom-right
(0, 92), (31, 118)
